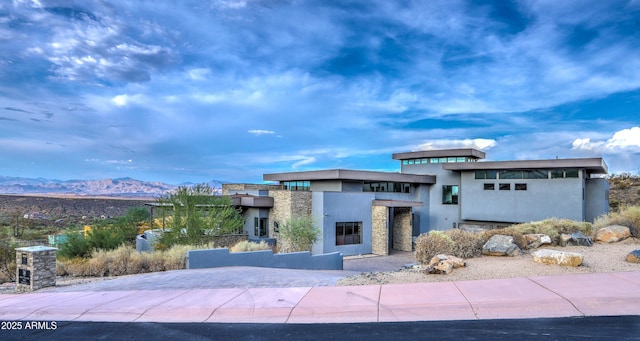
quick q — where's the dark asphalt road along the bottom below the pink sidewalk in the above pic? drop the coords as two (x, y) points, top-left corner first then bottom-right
(5, 316), (640, 341)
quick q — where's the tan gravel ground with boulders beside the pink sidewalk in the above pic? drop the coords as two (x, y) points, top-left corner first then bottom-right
(337, 238), (640, 285)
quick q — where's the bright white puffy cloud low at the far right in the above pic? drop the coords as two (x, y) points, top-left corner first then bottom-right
(572, 127), (640, 153)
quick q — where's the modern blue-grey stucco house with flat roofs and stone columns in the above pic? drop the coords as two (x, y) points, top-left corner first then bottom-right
(223, 149), (609, 255)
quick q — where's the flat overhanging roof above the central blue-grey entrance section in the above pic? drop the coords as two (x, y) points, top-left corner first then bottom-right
(262, 169), (436, 184)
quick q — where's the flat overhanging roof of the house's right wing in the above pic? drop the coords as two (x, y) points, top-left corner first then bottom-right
(442, 158), (609, 174)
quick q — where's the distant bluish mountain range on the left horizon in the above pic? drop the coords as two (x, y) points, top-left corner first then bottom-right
(0, 176), (222, 197)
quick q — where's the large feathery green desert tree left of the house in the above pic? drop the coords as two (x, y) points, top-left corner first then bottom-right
(157, 184), (243, 247)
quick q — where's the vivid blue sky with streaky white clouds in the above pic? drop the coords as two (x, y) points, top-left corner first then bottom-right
(0, 0), (640, 184)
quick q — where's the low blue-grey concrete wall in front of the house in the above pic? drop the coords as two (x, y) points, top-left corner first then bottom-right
(187, 249), (342, 270)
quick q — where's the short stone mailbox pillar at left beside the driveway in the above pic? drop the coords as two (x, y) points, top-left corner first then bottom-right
(16, 246), (58, 291)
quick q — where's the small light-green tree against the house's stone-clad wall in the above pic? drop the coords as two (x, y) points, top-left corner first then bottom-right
(280, 216), (320, 253)
